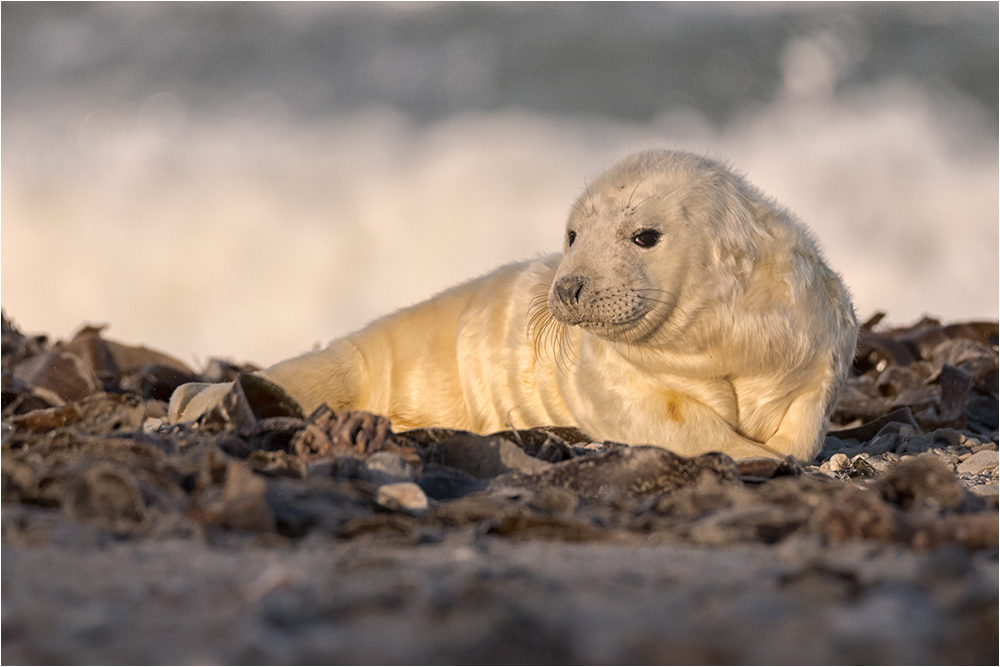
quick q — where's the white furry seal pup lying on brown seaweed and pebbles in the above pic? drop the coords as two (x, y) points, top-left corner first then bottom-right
(170, 150), (858, 461)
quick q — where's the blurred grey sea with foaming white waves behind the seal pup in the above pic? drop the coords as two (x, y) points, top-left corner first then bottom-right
(0, 2), (1000, 367)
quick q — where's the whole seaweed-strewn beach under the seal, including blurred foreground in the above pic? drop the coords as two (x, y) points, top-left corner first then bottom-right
(2, 319), (1000, 665)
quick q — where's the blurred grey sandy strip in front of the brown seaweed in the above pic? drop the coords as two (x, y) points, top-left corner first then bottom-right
(3, 508), (998, 664)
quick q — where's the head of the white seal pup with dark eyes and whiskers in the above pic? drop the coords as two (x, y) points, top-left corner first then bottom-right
(548, 151), (752, 343)
